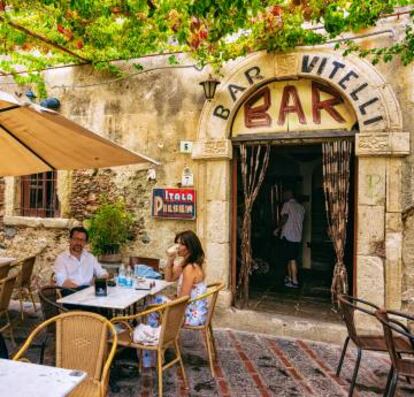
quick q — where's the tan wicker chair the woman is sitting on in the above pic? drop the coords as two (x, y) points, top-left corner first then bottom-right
(183, 283), (224, 378)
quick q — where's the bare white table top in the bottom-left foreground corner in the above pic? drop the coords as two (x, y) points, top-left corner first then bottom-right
(0, 359), (86, 397)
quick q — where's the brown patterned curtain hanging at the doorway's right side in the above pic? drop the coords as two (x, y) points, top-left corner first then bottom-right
(322, 140), (352, 302)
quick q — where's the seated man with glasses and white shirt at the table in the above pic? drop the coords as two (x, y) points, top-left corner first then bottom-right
(54, 227), (108, 289)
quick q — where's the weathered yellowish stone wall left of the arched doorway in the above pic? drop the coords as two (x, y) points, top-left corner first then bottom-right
(0, 56), (202, 282)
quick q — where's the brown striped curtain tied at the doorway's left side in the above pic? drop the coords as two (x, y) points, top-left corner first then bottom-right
(237, 143), (270, 307)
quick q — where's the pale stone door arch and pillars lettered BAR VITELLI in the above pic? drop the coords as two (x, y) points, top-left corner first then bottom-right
(192, 48), (410, 324)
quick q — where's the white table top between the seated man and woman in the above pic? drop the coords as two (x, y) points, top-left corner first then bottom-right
(57, 280), (174, 310)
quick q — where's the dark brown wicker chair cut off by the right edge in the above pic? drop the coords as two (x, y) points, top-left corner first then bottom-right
(375, 309), (414, 397)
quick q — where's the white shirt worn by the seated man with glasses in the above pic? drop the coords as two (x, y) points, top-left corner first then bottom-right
(54, 250), (108, 286)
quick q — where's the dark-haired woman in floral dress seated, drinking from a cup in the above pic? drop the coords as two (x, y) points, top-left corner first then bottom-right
(144, 230), (208, 367)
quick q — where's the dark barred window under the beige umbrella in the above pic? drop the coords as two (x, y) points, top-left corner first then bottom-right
(20, 171), (59, 218)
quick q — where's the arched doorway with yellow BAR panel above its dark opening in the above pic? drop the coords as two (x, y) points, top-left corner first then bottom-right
(231, 78), (357, 318)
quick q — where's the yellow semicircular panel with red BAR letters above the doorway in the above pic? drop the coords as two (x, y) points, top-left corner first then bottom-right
(232, 79), (356, 137)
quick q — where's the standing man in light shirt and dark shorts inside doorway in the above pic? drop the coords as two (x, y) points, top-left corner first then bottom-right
(274, 190), (305, 288)
